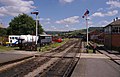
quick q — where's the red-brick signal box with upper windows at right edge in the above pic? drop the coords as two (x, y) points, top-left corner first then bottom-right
(104, 19), (120, 50)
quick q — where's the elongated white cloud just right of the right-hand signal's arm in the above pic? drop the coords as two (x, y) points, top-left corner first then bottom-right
(92, 10), (118, 17)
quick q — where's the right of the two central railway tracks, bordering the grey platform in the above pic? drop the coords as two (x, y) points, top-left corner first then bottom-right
(35, 41), (81, 77)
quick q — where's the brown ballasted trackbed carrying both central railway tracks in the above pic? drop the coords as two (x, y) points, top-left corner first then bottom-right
(0, 40), (81, 77)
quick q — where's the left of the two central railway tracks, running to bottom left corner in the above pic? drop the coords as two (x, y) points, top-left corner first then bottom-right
(0, 40), (81, 77)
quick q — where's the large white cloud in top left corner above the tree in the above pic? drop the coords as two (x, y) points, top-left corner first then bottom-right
(0, 0), (35, 16)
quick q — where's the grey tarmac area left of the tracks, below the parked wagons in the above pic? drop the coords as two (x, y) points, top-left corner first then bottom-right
(0, 51), (37, 65)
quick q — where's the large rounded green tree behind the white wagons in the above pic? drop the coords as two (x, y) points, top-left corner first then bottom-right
(7, 13), (43, 35)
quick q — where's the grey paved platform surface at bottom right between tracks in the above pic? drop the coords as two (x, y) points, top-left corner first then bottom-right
(71, 54), (120, 77)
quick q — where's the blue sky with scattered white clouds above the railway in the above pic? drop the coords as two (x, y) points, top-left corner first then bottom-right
(0, 0), (120, 31)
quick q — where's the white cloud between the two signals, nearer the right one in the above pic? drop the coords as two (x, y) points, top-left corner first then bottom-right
(56, 16), (79, 24)
